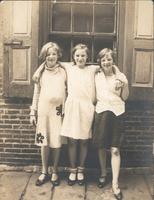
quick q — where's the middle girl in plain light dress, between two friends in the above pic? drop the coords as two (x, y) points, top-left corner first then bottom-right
(61, 44), (98, 185)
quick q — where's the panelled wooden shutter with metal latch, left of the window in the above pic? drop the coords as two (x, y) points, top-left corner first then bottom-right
(2, 1), (39, 97)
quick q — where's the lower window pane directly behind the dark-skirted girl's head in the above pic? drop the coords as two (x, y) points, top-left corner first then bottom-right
(94, 38), (113, 62)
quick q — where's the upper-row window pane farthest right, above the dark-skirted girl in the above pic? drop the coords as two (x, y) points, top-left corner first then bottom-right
(94, 5), (115, 33)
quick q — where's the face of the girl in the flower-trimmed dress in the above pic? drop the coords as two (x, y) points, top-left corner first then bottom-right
(46, 48), (58, 68)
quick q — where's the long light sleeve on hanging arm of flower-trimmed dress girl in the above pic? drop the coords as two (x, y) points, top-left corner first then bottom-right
(30, 83), (41, 115)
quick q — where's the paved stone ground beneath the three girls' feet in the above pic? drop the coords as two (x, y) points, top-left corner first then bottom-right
(0, 171), (153, 200)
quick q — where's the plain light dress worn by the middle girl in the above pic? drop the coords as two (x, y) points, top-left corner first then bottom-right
(61, 65), (98, 139)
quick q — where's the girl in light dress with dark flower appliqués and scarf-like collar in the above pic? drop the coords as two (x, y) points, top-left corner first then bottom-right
(30, 42), (66, 186)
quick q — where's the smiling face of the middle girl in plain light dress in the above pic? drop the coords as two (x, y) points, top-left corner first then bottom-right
(73, 49), (88, 68)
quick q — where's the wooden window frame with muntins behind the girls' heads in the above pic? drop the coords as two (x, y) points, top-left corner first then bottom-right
(48, 0), (119, 63)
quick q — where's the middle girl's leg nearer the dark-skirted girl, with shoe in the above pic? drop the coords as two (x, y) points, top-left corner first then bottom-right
(77, 140), (88, 185)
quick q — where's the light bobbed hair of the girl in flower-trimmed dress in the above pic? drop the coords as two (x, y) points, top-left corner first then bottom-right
(39, 42), (62, 62)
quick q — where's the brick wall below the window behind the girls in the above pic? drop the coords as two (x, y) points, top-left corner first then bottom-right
(0, 3), (154, 167)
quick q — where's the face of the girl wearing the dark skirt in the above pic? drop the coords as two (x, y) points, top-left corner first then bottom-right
(101, 53), (113, 73)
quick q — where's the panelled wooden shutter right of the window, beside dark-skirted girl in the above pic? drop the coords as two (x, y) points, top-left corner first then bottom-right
(124, 0), (154, 101)
